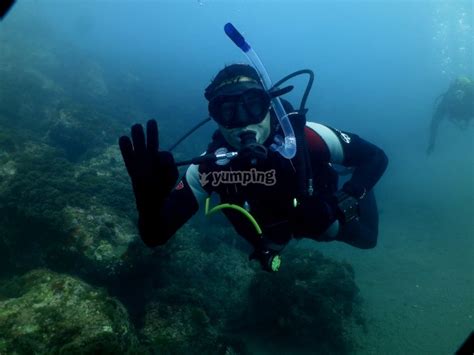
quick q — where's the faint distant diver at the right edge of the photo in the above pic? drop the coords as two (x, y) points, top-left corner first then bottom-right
(426, 77), (474, 154)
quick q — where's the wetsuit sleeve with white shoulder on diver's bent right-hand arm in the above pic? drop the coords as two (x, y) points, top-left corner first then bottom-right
(307, 122), (388, 198)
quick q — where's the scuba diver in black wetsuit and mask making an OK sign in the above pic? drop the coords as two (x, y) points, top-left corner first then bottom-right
(119, 64), (388, 271)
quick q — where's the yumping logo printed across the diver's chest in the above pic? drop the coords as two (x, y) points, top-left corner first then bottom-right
(199, 168), (276, 186)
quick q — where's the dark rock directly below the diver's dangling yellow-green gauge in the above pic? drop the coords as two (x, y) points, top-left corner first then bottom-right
(244, 248), (360, 354)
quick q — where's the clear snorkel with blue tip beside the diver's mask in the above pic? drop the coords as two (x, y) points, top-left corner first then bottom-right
(224, 22), (296, 159)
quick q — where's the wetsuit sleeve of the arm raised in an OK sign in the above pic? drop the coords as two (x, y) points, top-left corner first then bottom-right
(138, 165), (207, 248)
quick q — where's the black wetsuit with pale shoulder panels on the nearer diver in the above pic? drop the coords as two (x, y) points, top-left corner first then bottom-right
(139, 118), (388, 252)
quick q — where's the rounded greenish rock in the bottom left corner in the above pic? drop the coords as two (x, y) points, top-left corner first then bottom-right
(0, 269), (137, 354)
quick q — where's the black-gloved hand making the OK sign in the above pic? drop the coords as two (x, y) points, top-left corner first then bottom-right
(119, 120), (178, 214)
